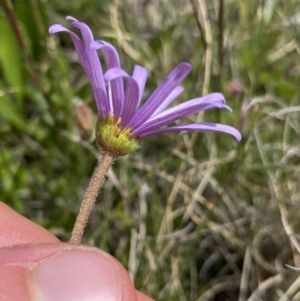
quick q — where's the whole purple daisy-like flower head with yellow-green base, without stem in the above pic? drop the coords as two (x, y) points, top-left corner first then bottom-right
(49, 17), (241, 156)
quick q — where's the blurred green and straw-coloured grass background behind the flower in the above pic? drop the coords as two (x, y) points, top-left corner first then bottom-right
(0, 0), (300, 301)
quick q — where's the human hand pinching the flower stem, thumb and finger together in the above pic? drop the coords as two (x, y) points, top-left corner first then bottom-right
(0, 202), (153, 301)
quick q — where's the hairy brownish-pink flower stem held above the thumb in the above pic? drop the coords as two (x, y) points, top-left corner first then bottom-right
(70, 153), (115, 243)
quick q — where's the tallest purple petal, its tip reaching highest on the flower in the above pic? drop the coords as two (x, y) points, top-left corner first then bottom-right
(67, 17), (109, 117)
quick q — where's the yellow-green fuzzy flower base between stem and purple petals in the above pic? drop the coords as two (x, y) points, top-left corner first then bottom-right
(96, 114), (139, 157)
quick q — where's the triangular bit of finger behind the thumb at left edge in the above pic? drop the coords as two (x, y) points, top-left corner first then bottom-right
(0, 202), (59, 247)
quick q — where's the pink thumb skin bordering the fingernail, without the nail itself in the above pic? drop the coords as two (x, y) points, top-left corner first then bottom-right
(0, 243), (138, 301)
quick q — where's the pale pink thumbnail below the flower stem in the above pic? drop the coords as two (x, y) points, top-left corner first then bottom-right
(28, 249), (122, 301)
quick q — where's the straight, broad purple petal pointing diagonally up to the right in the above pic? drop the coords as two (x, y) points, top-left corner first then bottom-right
(129, 63), (192, 128)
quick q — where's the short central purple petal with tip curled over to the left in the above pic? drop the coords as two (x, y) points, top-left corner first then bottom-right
(104, 68), (139, 128)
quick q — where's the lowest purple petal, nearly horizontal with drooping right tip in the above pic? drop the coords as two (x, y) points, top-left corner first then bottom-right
(140, 123), (242, 141)
